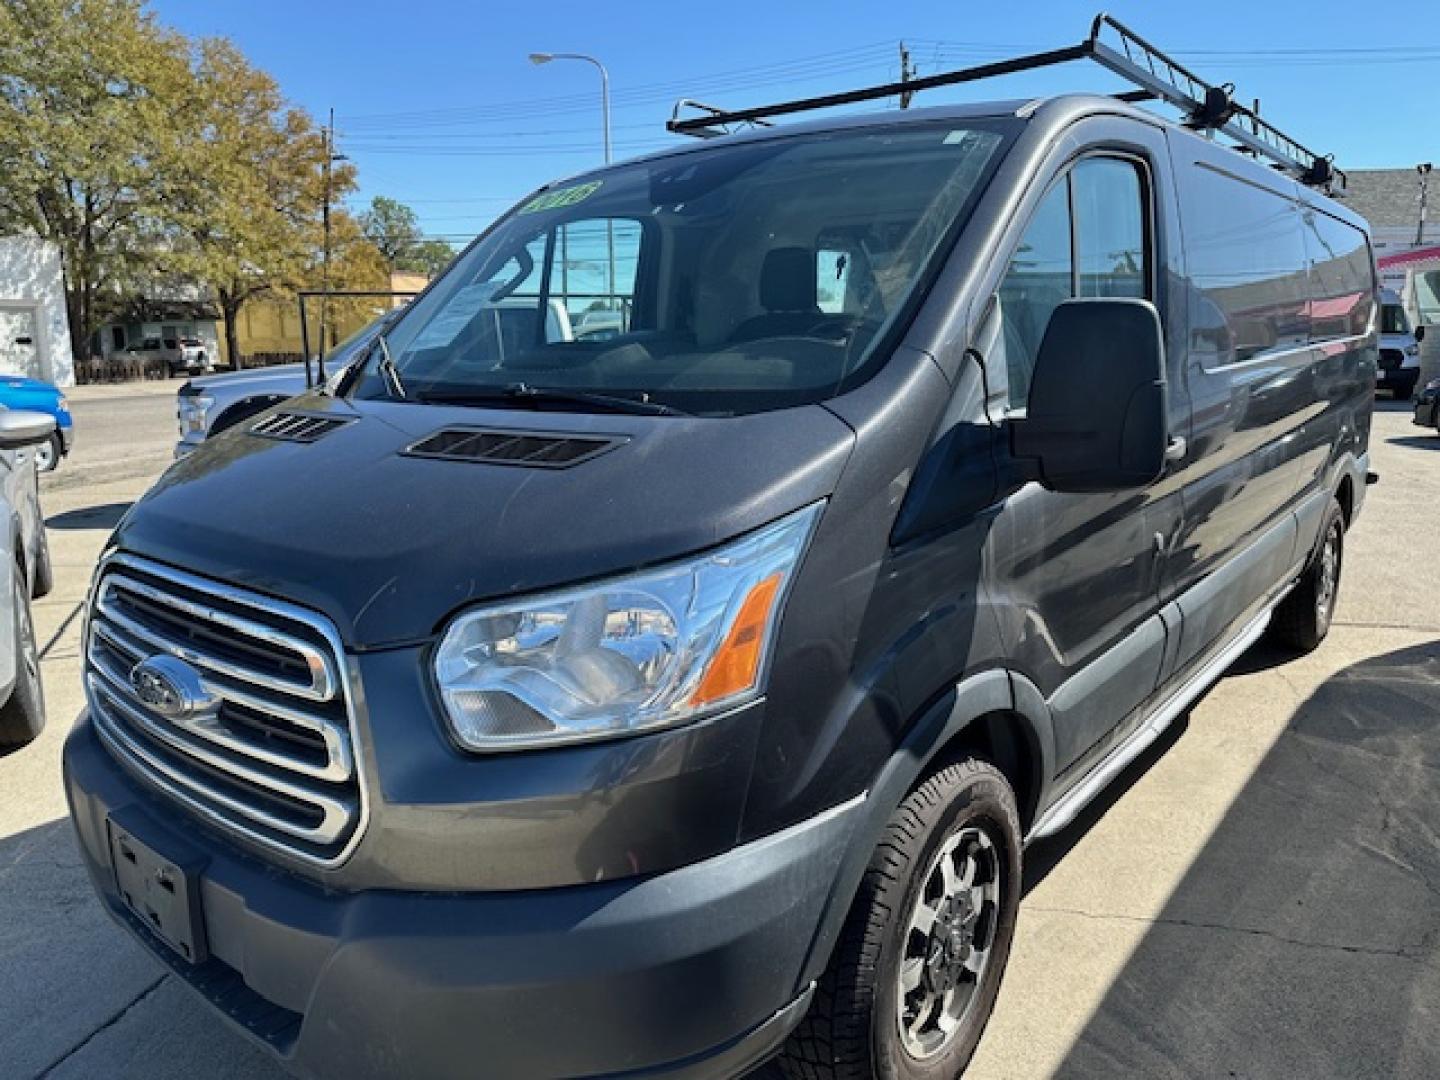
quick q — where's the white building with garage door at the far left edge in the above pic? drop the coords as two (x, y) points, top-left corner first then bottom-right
(0, 236), (75, 386)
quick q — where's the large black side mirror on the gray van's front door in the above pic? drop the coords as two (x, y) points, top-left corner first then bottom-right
(1009, 298), (1169, 491)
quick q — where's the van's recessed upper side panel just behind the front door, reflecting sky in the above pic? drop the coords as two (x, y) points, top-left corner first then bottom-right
(1181, 163), (1310, 367)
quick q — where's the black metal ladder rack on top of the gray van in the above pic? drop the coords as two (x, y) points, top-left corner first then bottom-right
(665, 14), (1345, 192)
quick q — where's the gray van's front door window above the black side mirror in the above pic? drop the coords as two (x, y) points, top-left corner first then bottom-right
(999, 157), (1151, 409)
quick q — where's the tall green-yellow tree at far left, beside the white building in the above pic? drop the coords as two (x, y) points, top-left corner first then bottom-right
(0, 0), (192, 360)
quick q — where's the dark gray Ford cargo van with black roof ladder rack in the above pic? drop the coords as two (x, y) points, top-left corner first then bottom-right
(65, 22), (1377, 1080)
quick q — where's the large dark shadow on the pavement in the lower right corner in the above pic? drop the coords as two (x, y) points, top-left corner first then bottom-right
(1057, 641), (1440, 1077)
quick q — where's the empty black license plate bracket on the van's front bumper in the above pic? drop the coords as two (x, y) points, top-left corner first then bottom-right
(107, 818), (210, 963)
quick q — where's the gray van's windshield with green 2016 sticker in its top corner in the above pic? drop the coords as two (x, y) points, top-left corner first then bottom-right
(353, 120), (1015, 415)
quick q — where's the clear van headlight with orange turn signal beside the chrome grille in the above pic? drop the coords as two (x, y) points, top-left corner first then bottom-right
(435, 504), (821, 750)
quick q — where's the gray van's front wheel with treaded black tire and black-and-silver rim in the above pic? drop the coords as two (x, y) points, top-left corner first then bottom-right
(780, 757), (1021, 1080)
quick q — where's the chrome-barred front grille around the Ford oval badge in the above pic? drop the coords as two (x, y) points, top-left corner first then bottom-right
(85, 554), (366, 865)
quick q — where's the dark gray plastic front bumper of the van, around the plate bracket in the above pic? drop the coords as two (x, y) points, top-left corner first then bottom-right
(65, 717), (861, 1080)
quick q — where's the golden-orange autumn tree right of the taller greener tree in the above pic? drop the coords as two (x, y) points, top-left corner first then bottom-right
(171, 39), (342, 366)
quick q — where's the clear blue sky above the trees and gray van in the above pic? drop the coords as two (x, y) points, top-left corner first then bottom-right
(151, 0), (1440, 240)
